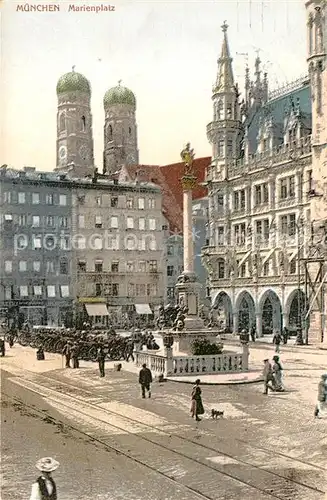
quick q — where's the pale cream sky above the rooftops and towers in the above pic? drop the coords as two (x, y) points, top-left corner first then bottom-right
(0, 0), (307, 171)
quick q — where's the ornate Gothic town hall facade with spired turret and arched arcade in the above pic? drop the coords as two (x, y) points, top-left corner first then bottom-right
(202, 10), (322, 336)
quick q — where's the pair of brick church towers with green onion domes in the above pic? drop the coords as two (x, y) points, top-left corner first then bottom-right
(55, 67), (139, 177)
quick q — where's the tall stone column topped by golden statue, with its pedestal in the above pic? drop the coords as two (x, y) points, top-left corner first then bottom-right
(176, 143), (203, 331)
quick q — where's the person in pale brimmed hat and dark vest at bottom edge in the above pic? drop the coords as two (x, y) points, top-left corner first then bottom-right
(30, 457), (59, 500)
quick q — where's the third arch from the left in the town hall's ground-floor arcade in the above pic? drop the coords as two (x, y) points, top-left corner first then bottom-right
(259, 290), (283, 335)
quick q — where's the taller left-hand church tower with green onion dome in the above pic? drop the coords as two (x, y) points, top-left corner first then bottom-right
(55, 67), (94, 177)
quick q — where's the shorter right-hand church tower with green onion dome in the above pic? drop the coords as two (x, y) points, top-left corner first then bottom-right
(103, 82), (139, 175)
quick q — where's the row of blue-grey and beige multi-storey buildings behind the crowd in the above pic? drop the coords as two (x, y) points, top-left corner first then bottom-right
(0, 167), (170, 325)
